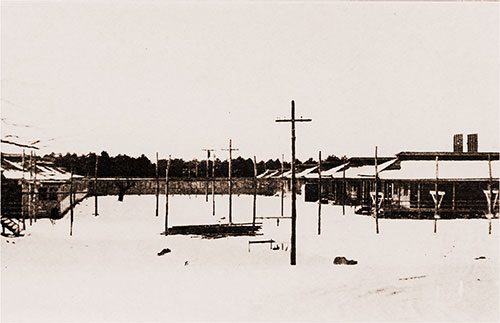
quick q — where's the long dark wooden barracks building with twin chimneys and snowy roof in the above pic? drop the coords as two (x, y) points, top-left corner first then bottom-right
(301, 134), (499, 218)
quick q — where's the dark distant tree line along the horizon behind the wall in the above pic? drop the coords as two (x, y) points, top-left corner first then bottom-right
(44, 151), (345, 178)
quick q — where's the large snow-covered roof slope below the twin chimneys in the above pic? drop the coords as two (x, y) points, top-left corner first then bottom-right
(379, 160), (500, 179)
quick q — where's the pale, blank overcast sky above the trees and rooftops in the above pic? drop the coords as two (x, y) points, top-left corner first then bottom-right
(1, 1), (500, 160)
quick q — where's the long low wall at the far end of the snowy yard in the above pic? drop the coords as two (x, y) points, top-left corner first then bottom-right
(88, 178), (287, 196)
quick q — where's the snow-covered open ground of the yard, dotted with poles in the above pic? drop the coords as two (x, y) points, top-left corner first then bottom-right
(1, 196), (499, 322)
